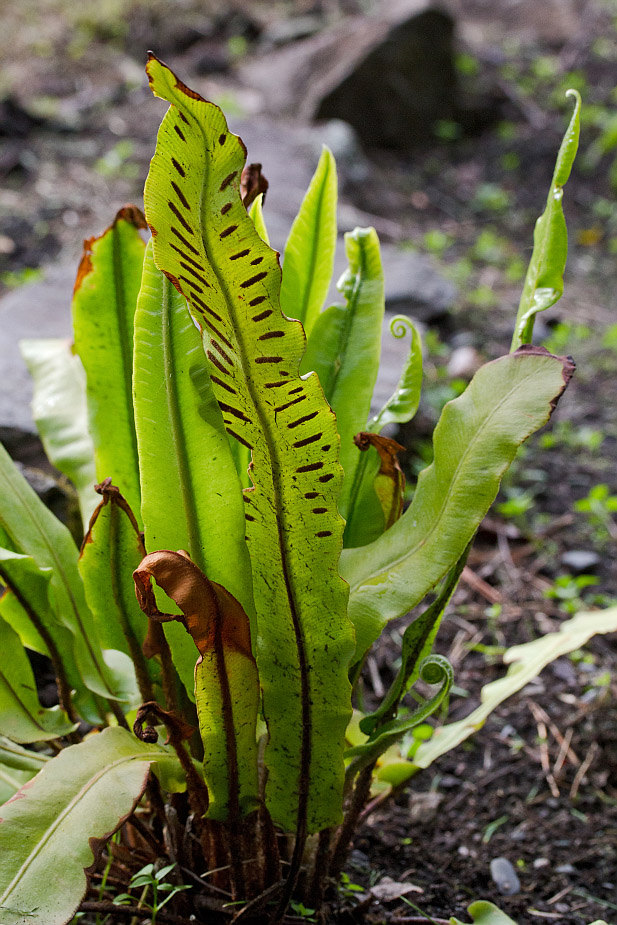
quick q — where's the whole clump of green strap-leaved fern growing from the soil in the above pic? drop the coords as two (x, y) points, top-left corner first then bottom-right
(0, 55), (592, 925)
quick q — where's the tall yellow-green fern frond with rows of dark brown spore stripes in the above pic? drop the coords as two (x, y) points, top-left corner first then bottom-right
(145, 57), (353, 832)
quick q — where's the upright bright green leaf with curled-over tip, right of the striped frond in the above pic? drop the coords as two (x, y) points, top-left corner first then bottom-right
(302, 228), (384, 519)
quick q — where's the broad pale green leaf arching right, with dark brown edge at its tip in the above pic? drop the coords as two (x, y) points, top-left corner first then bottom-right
(341, 347), (574, 658)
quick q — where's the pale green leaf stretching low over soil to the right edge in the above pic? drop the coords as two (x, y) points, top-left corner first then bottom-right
(413, 607), (617, 768)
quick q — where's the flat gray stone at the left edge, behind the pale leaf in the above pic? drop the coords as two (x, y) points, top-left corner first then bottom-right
(0, 264), (75, 431)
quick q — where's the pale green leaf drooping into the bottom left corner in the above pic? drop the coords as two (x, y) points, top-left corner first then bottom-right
(0, 726), (184, 925)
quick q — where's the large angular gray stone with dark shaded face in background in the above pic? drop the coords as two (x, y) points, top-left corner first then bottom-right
(239, 0), (458, 150)
